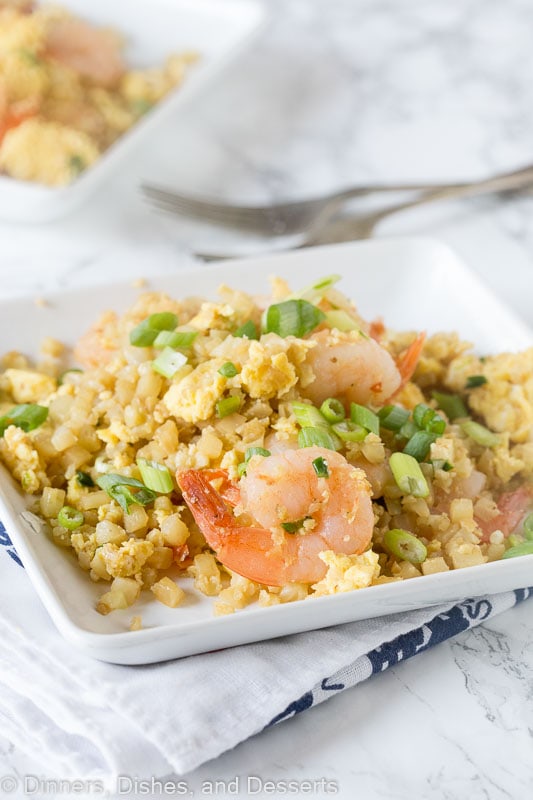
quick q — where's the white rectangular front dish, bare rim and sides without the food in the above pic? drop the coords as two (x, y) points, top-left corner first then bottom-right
(0, 239), (533, 664)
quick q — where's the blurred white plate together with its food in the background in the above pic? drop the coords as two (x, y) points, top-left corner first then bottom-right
(0, 0), (264, 222)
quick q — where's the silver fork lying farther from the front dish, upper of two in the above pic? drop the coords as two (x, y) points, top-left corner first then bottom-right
(141, 166), (533, 238)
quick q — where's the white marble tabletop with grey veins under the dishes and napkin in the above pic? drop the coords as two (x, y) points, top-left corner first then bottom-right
(0, 0), (533, 800)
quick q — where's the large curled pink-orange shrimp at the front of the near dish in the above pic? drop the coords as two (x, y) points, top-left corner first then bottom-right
(176, 447), (374, 586)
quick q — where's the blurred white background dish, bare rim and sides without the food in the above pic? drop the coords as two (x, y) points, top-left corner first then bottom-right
(0, 0), (265, 222)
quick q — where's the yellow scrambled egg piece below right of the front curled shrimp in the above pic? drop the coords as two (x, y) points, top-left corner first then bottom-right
(312, 550), (380, 597)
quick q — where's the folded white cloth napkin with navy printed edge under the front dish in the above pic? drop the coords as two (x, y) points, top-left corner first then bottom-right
(0, 530), (533, 786)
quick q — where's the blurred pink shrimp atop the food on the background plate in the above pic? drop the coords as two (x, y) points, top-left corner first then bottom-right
(47, 18), (125, 88)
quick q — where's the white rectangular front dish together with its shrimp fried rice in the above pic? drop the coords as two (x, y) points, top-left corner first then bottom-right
(0, 239), (533, 664)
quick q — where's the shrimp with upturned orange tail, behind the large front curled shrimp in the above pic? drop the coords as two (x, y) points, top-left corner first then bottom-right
(303, 330), (425, 406)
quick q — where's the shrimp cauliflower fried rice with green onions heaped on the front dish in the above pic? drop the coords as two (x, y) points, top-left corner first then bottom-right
(0, 279), (533, 629)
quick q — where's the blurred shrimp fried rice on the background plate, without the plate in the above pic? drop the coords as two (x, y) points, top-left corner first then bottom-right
(0, 0), (198, 186)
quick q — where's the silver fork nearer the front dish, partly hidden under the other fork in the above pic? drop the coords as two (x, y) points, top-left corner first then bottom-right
(190, 167), (533, 261)
